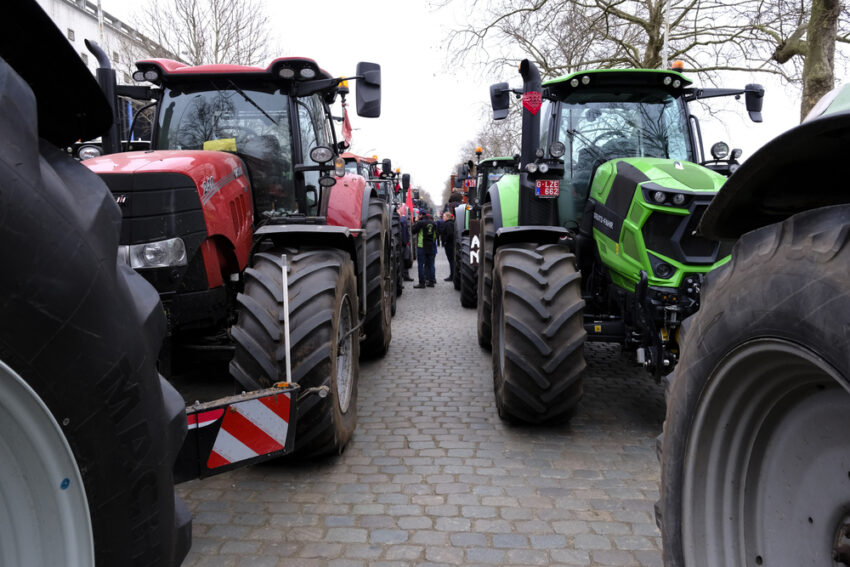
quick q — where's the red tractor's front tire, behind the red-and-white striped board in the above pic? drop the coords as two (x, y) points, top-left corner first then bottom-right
(230, 248), (360, 458)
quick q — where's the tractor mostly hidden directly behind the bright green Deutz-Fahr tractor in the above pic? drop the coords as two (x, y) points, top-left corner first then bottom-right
(454, 153), (519, 308)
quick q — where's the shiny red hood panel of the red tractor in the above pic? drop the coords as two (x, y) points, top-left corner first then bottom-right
(82, 150), (254, 276)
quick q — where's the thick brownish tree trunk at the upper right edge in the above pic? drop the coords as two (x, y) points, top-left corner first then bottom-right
(800, 0), (841, 120)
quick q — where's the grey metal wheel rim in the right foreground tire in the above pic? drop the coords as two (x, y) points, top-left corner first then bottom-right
(682, 339), (850, 566)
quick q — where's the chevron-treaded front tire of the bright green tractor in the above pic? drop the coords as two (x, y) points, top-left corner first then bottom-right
(493, 244), (586, 423)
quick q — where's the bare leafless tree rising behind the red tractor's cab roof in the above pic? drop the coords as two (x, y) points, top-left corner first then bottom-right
(137, 0), (269, 65)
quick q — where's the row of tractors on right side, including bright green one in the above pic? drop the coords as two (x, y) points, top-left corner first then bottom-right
(454, 48), (850, 566)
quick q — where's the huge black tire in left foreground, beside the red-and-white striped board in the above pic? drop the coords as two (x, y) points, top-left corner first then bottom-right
(0, 60), (191, 566)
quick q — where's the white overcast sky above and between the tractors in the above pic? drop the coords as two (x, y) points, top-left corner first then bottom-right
(102, 0), (799, 202)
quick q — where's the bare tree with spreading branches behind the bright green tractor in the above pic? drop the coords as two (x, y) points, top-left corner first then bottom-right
(450, 0), (850, 118)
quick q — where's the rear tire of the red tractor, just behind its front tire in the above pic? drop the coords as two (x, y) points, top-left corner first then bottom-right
(360, 198), (395, 358)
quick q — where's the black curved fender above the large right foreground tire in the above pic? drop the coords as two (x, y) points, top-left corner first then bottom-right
(699, 111), (850, 239)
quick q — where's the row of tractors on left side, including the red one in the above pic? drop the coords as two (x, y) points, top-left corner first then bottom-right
(0, 1), (422, 565)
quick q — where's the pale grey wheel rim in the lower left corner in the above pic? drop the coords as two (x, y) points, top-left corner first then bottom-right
(0, 361), (94, 565)
